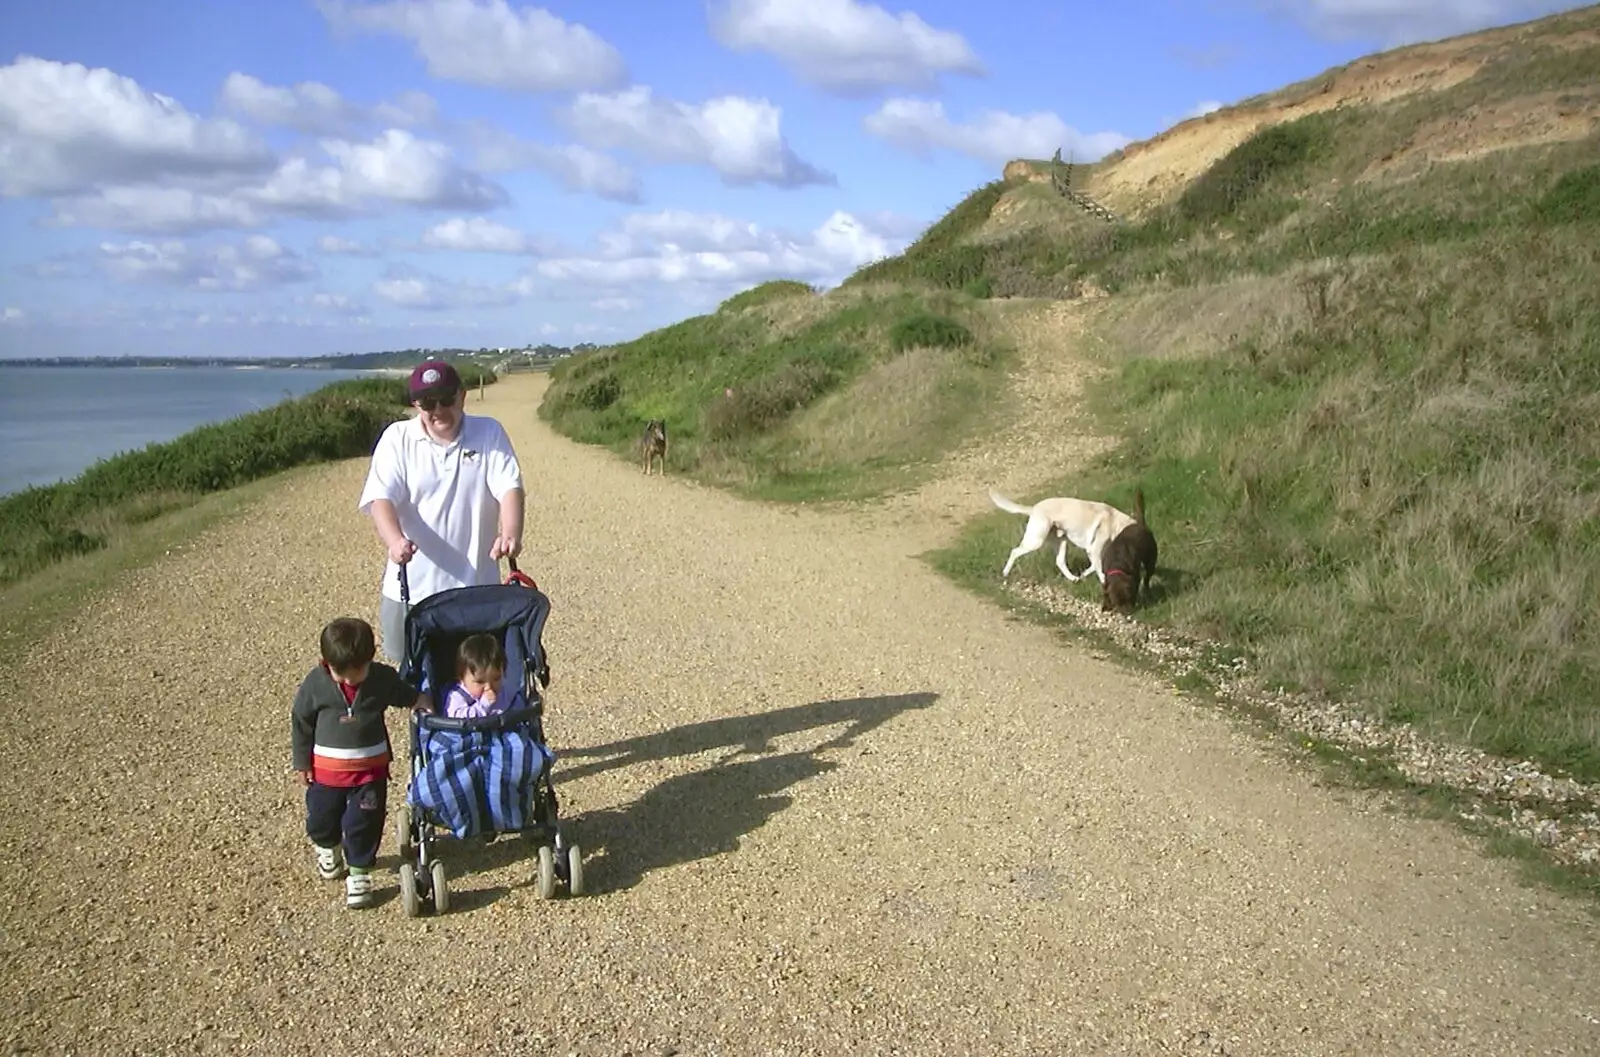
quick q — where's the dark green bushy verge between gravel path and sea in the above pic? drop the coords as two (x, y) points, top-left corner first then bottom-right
(0, 365), (494, 588)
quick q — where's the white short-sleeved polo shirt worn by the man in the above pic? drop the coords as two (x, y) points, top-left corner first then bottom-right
(360, 414), (522, 603)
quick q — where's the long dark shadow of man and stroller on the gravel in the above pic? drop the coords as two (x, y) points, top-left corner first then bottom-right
(557, 694), (939, 892)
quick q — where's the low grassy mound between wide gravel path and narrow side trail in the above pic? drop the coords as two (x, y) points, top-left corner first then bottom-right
(539, 276), (1006, 499)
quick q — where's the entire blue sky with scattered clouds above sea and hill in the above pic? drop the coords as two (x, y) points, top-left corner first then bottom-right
(0, 0), (1578, 357)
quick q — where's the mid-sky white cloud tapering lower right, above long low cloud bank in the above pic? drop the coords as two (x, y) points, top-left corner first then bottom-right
(563, 85), (835, 187)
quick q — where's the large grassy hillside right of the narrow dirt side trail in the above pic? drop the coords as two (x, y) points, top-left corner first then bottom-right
(934, 8), (1600, 780)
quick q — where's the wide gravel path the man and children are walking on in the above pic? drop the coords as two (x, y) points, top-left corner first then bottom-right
(0, 376), (1600, 1057)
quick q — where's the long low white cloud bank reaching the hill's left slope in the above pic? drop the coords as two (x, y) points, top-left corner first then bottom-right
(533, 209), (906, 291)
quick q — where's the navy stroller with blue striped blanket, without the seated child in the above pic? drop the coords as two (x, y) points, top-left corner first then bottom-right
(395, 560), (584, 918)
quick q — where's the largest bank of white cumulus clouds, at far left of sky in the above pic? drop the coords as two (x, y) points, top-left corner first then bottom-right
(0, 56), (509, 235)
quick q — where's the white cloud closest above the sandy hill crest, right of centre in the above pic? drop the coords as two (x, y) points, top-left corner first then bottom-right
(862, 99), (1131, 165)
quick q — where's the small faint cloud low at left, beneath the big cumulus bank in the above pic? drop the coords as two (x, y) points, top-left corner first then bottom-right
(93, 235), (317, 291)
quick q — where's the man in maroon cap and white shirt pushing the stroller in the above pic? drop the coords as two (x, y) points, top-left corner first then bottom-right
(360, 360), (523, 664)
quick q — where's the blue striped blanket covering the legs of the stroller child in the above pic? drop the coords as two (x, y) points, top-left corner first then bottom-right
(406, 729), (555, 838)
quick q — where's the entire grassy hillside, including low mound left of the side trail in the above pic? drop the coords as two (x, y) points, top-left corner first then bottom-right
(544, 8), (1600, 780)
